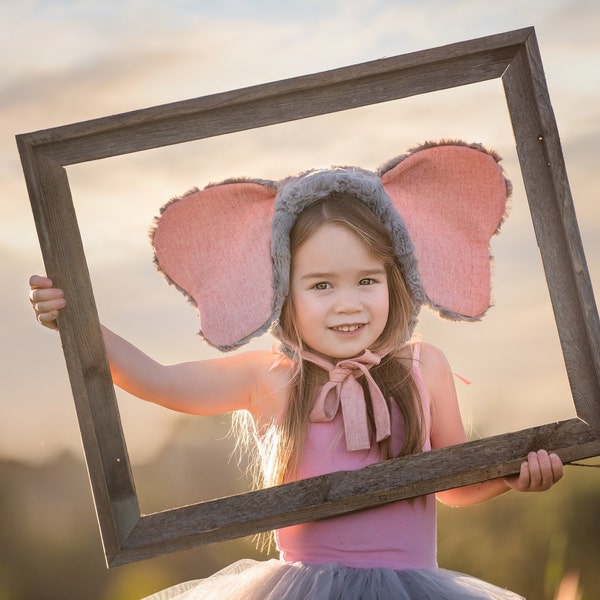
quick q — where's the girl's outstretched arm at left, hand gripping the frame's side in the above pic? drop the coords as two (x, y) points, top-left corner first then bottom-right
(29, 276), (272, 415)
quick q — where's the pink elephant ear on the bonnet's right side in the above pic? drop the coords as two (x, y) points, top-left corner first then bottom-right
(380, 142), (510, 320)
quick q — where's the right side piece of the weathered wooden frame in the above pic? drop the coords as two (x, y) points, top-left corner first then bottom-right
(503, 34), (600, 431)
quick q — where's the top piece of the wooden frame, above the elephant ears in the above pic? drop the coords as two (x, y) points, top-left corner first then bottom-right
(15, 29), (530, 165)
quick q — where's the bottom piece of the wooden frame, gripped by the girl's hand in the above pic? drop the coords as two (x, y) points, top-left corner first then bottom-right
(112, 419), (600, 564)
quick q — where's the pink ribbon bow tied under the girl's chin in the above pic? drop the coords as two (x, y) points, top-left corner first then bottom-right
(301, 350), (391, 450)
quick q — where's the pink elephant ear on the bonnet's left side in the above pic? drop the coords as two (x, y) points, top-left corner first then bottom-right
(151, 181), (276, 350)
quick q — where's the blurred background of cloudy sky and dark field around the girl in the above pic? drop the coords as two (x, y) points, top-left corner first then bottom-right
(0, 0), (600, 600)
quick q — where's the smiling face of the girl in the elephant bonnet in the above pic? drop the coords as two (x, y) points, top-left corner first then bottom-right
(290, 224), (389, 359)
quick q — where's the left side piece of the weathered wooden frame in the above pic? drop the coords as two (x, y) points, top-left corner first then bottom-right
(19, 143), (140, 556)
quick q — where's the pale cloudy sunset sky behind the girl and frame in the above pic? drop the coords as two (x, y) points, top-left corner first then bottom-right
(0, 0), (600, 462)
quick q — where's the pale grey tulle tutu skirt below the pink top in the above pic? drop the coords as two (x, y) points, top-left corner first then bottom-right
(145, 559), (523, 600)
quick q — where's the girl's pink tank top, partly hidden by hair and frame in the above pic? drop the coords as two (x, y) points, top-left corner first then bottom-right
(275, 343), (437, 570)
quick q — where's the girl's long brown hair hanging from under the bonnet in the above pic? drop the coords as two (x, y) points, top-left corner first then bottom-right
(262, 193), (424, 485)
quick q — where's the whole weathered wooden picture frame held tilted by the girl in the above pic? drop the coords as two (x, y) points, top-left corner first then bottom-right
(17, 28), (600, 566)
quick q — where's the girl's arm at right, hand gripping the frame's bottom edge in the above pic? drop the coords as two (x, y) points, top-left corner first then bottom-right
(421, 344), (563, 506)
